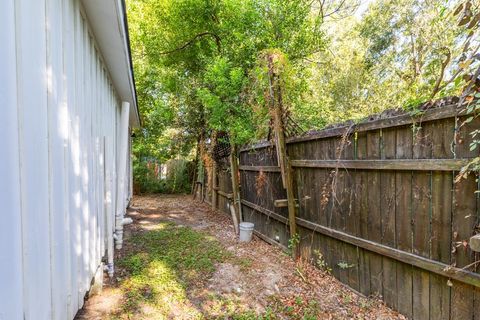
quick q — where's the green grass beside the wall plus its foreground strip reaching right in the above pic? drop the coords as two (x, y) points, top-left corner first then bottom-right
(110, 222), (324, 320)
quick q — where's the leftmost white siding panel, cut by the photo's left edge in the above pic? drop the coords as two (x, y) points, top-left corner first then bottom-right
(0, 0), (23, 320)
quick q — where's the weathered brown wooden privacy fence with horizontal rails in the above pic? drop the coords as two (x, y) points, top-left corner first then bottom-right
(206, 105), (480, 319)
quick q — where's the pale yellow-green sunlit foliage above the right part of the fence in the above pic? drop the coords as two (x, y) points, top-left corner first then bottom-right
(310, 0), (475, 126)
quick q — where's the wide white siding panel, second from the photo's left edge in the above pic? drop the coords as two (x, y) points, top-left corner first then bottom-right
(15, 0), (52, 319)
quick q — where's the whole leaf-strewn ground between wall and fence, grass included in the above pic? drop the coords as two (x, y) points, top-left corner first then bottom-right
(76, 195), (404, 320)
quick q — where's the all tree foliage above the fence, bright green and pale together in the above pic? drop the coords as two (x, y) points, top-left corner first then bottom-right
(127, 0), (479, 192)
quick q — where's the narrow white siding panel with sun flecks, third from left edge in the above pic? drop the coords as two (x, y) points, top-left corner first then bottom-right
(46, 0), (71, 319)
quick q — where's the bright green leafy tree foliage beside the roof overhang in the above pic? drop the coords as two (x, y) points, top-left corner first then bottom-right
(127, 0), (352, 188)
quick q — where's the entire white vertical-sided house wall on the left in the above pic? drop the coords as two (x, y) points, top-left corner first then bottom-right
(0, 0), (130, 320)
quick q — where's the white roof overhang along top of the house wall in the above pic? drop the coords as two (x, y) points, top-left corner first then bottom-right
(82, 0), (141, 127)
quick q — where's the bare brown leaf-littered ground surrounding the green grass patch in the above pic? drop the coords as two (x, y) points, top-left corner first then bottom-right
(76, 195), (405, 320)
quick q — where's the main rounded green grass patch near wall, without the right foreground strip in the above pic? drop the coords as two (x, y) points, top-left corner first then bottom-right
(113, 223), (231, 319)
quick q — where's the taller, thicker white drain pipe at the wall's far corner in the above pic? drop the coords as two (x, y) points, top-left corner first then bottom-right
(115, 101), (130, 249)
